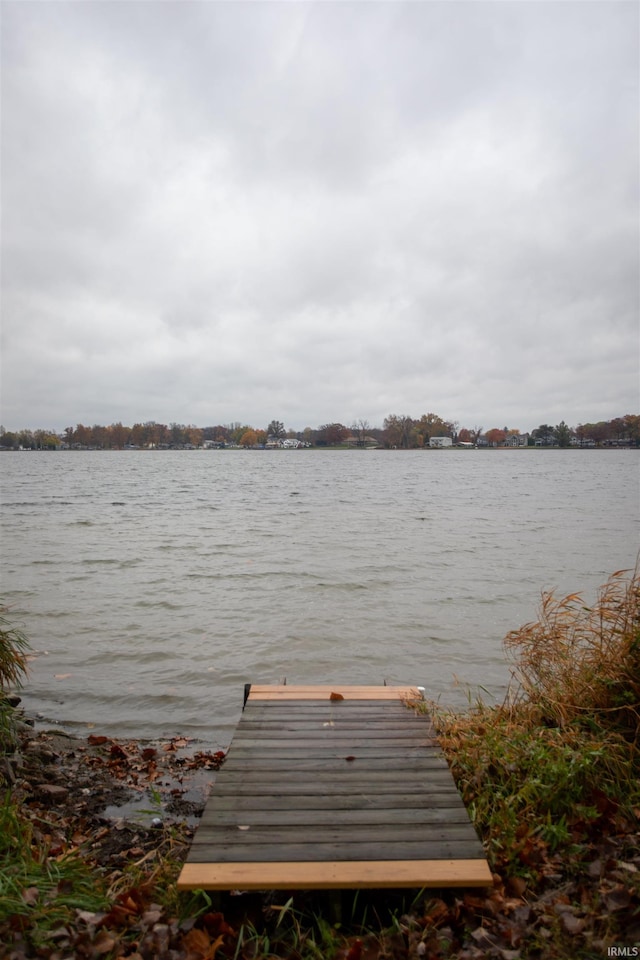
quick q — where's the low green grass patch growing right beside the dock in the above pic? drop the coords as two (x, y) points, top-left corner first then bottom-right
(436, 707), (640, 877)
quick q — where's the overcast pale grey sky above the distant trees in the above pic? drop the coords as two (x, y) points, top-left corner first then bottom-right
(1, 0), (640, 432)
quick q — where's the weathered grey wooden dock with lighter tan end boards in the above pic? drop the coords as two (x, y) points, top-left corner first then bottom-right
(178, 685), (491, 890)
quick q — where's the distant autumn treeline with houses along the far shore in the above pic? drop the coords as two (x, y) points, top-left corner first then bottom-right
(0, 413), (640, 450)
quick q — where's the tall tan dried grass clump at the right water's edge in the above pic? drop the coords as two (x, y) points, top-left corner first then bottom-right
(505, 565), (640, 742)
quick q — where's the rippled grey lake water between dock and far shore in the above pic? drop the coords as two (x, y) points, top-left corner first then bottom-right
(0, 450), (640, 748)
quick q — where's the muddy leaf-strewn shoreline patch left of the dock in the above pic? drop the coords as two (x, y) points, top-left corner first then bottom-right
(0, 697), (224, 869)
